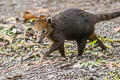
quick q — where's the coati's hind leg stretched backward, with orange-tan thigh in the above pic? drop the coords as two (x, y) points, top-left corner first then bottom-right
(89, 32), (106, 50)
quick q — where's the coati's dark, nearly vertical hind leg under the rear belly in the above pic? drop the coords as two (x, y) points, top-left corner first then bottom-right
(77, 38), (87, 57)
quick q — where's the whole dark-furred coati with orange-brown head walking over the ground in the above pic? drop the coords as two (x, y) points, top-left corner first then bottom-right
(34, 8), (120, 57)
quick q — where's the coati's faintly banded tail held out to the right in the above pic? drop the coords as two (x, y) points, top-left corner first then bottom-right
(95, 11), (120, 23)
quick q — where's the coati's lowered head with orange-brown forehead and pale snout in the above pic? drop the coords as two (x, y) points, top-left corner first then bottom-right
(34, 15), (52, 42)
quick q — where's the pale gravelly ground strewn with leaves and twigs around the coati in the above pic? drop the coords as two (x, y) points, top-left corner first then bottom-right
(0, 0), (120, 80)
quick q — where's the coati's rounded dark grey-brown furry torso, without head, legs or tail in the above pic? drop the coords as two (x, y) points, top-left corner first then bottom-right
(52, 8), (96, 40)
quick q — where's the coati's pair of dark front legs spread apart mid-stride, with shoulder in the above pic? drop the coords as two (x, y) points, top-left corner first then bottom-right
(45, 33), (65, 57)
